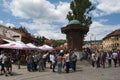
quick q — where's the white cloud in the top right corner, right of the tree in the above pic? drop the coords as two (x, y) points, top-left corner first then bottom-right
(91, 0), (120, 17)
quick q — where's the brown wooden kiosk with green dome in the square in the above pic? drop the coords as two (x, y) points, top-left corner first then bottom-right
(61, 20), (89, 50)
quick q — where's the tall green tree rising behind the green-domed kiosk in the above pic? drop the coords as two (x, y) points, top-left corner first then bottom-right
(66, 0), (95, 27)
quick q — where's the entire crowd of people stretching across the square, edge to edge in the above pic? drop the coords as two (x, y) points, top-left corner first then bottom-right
(0, 49), (120, 76)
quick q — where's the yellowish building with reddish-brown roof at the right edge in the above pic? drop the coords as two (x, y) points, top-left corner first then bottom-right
(102, 29), (120, 50)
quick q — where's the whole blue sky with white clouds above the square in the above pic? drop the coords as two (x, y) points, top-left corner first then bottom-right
(0, 0), (120, 40)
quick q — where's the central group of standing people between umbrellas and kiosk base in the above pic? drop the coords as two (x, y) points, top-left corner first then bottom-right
(26, 50), (77, 73)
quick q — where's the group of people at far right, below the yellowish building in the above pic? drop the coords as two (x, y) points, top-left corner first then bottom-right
(90, 50), (120, 68)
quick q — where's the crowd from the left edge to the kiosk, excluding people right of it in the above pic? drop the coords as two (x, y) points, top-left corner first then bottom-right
(0, 50), (77, 76)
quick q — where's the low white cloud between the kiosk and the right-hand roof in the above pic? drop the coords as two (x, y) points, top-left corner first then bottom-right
(85, 22), (120, 40)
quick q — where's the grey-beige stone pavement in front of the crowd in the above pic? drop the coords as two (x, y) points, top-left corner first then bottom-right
(0, 62), (120, 80)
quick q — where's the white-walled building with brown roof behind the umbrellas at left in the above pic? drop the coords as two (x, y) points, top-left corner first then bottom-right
(0, 25), (38, 43)
